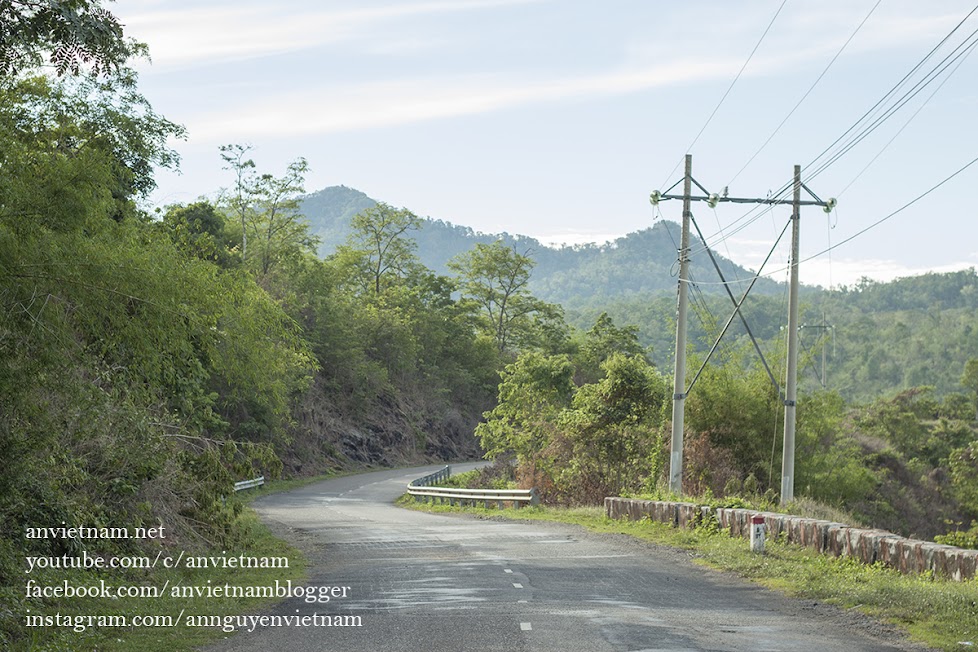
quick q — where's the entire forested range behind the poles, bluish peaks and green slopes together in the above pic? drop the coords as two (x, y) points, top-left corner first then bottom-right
(301, 186), (978, 400)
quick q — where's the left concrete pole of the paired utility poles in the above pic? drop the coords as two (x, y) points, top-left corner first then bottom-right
(669, 154), (693, 494)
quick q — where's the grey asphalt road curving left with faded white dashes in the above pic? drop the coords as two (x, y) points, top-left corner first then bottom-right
(207, 467), (922, 652)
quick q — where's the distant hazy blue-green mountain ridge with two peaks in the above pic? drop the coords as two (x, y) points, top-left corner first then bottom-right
(301, 186), (783, 308)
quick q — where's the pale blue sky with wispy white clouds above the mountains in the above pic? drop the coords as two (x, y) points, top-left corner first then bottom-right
(118, 0), (978, 287)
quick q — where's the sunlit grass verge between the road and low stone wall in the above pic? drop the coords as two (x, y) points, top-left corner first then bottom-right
(398, 497), (978, 650)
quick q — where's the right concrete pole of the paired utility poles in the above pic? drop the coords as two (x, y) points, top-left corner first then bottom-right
(781, 165), (801, 505)
